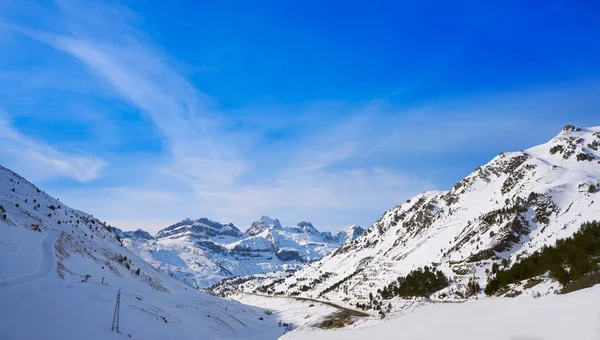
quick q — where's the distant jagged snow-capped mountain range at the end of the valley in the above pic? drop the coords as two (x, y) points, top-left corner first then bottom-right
(112, 216), (364, 288)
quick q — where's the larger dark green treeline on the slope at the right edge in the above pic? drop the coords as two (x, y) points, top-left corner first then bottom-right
(485, 221), (600, 295)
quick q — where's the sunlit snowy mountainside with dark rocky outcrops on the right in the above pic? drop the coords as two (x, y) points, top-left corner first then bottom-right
(246, 125), (600, 302)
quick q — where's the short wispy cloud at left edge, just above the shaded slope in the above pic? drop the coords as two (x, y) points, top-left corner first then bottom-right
(0, 114), (107, 182)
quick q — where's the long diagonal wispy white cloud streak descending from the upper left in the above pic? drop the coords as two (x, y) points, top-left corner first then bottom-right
(44, 2), (245, 191)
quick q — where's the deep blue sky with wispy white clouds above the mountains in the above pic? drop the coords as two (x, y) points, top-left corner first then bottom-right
(0, 0), (600, 231)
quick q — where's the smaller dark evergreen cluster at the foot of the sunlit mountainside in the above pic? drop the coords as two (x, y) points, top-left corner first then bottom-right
(377, 266), (449, 300)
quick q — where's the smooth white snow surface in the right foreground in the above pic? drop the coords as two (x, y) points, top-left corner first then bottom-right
(281, 285), (600, 340)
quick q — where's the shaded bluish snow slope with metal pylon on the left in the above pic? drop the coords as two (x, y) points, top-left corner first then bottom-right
(0, 167), (290, 339)
